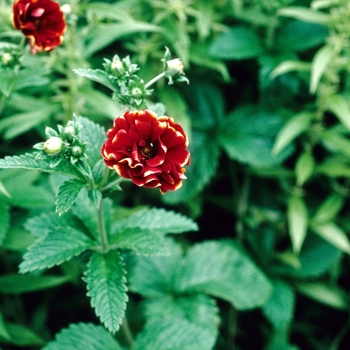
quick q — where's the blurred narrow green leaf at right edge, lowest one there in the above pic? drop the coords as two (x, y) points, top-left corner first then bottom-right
(295, 282), (349, 310)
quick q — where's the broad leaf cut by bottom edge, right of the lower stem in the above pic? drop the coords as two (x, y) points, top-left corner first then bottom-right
(132, 317), (214, 350)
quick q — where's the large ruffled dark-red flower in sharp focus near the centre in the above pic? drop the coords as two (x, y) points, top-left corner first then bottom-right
(101, 110), (190, 194)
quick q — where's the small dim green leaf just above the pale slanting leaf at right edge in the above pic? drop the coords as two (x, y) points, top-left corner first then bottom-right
(312, 193), (345, 225)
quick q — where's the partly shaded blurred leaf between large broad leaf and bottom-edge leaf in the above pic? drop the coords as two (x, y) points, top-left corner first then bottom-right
(144, 294), (220, 340)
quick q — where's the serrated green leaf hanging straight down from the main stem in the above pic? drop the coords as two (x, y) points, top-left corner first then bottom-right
(84, 250), (128, 333)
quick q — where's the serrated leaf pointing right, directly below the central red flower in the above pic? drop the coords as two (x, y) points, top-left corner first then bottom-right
(116, 208), (198, 235)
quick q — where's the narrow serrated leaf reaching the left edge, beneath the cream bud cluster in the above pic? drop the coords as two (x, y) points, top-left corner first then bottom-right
(0, 153), (82, 178)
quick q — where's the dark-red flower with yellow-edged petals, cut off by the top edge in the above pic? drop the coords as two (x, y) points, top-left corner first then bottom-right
(12, 0), (66, 54)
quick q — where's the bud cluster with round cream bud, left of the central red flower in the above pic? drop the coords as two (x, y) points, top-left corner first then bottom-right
(33, 116), (87, 168)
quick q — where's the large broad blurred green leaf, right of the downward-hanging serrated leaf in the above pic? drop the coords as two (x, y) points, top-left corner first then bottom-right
(178, 241), (271, 310)
